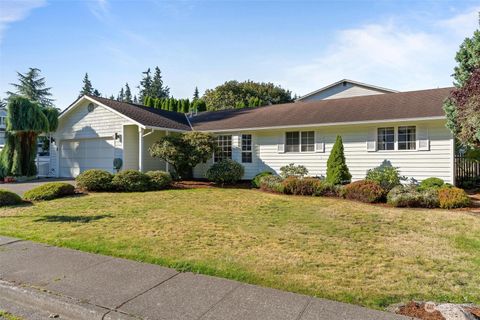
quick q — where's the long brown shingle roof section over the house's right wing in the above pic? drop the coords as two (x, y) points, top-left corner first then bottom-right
(189, 88), (452, 131)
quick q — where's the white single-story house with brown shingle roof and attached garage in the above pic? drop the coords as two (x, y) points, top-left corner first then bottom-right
(51, 82), (455, 183)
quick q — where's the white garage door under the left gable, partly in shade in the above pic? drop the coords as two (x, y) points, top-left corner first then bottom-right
(59, 138), (115, 177)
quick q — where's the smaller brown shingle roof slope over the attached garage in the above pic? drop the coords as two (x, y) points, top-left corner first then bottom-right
(89, 96), (191, 131)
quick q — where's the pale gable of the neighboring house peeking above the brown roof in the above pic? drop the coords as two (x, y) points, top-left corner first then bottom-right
(296, 79), (398, 102)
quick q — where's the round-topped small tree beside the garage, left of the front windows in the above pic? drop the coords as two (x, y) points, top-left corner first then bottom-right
(149, 132), (216, 179)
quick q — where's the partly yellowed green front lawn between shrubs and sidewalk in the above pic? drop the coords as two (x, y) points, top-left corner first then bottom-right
(0, 189), (480, 309)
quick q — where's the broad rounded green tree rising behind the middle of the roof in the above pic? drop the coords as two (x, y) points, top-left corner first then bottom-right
(203, 80), (293, 111)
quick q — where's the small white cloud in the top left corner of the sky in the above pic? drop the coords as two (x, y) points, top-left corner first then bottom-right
(0, 0), (47, 44)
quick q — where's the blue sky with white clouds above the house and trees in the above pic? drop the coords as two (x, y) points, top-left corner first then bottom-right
(0, 0), (480, 109)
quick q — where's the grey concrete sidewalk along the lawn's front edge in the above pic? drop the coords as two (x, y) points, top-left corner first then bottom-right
(0, 237), (409, 320)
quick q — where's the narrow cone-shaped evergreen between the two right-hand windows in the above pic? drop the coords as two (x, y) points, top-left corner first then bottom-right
(326, 136), (352, 185)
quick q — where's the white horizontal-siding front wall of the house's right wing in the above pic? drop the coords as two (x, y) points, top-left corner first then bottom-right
(194, 120), (454, 183)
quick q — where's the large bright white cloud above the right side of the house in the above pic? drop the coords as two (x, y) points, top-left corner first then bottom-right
(284, 8), (478, 94)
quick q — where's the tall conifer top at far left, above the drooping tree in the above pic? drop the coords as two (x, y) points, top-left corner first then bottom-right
(7, 68), (54, 107)
